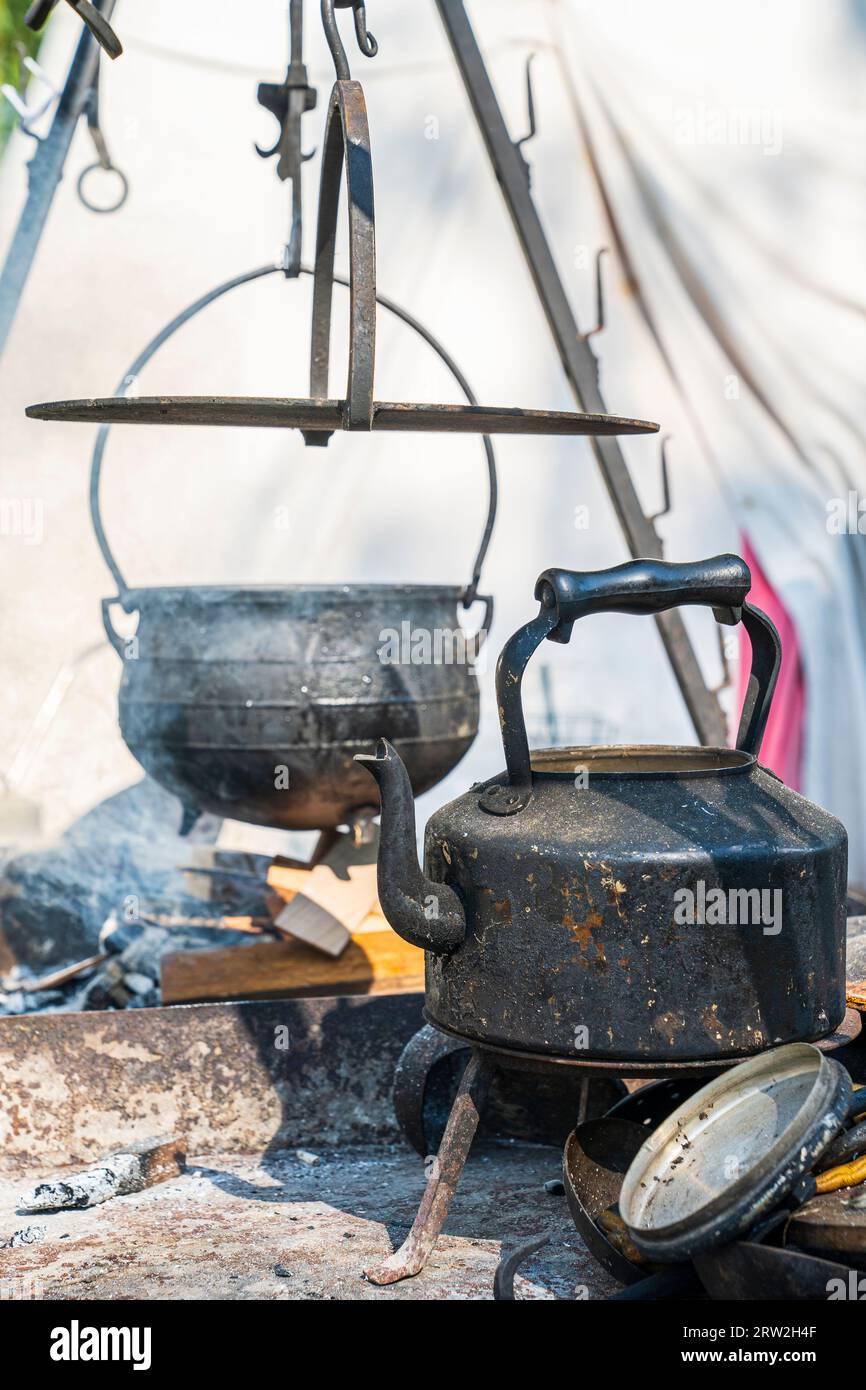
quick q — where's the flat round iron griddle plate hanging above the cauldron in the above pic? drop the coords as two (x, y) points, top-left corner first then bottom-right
(26, 396), (659, 435)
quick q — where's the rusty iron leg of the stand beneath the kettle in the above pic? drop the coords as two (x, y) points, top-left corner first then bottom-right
(364, 1048), (496, 1284)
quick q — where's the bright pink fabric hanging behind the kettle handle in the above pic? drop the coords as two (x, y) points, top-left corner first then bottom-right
(737, 535), (806, 791)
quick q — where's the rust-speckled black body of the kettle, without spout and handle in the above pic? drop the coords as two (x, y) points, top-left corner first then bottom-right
(425, 748), (848, 1062)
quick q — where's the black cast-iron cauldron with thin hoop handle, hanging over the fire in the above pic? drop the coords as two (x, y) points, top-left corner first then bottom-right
(90, 265), (496, 830)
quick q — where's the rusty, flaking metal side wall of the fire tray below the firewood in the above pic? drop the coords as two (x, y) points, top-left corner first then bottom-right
(0, 994), (421, 1172)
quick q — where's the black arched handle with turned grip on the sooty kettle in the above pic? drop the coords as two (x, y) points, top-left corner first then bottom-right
(480, 555), (781, 816)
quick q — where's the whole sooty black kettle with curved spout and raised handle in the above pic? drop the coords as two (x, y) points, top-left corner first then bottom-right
(360, 555), (847, 1062)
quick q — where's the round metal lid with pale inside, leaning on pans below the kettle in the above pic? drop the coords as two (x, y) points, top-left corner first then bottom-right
(620, 1043), (852, 1261)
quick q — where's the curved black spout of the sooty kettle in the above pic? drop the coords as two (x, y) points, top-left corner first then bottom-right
(354, 738), (466, 955)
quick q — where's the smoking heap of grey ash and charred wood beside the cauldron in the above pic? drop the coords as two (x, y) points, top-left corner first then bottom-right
(0, 778), (279, 1015)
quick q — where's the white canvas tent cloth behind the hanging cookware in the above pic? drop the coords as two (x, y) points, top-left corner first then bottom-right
(0, 0), (866, 880)
